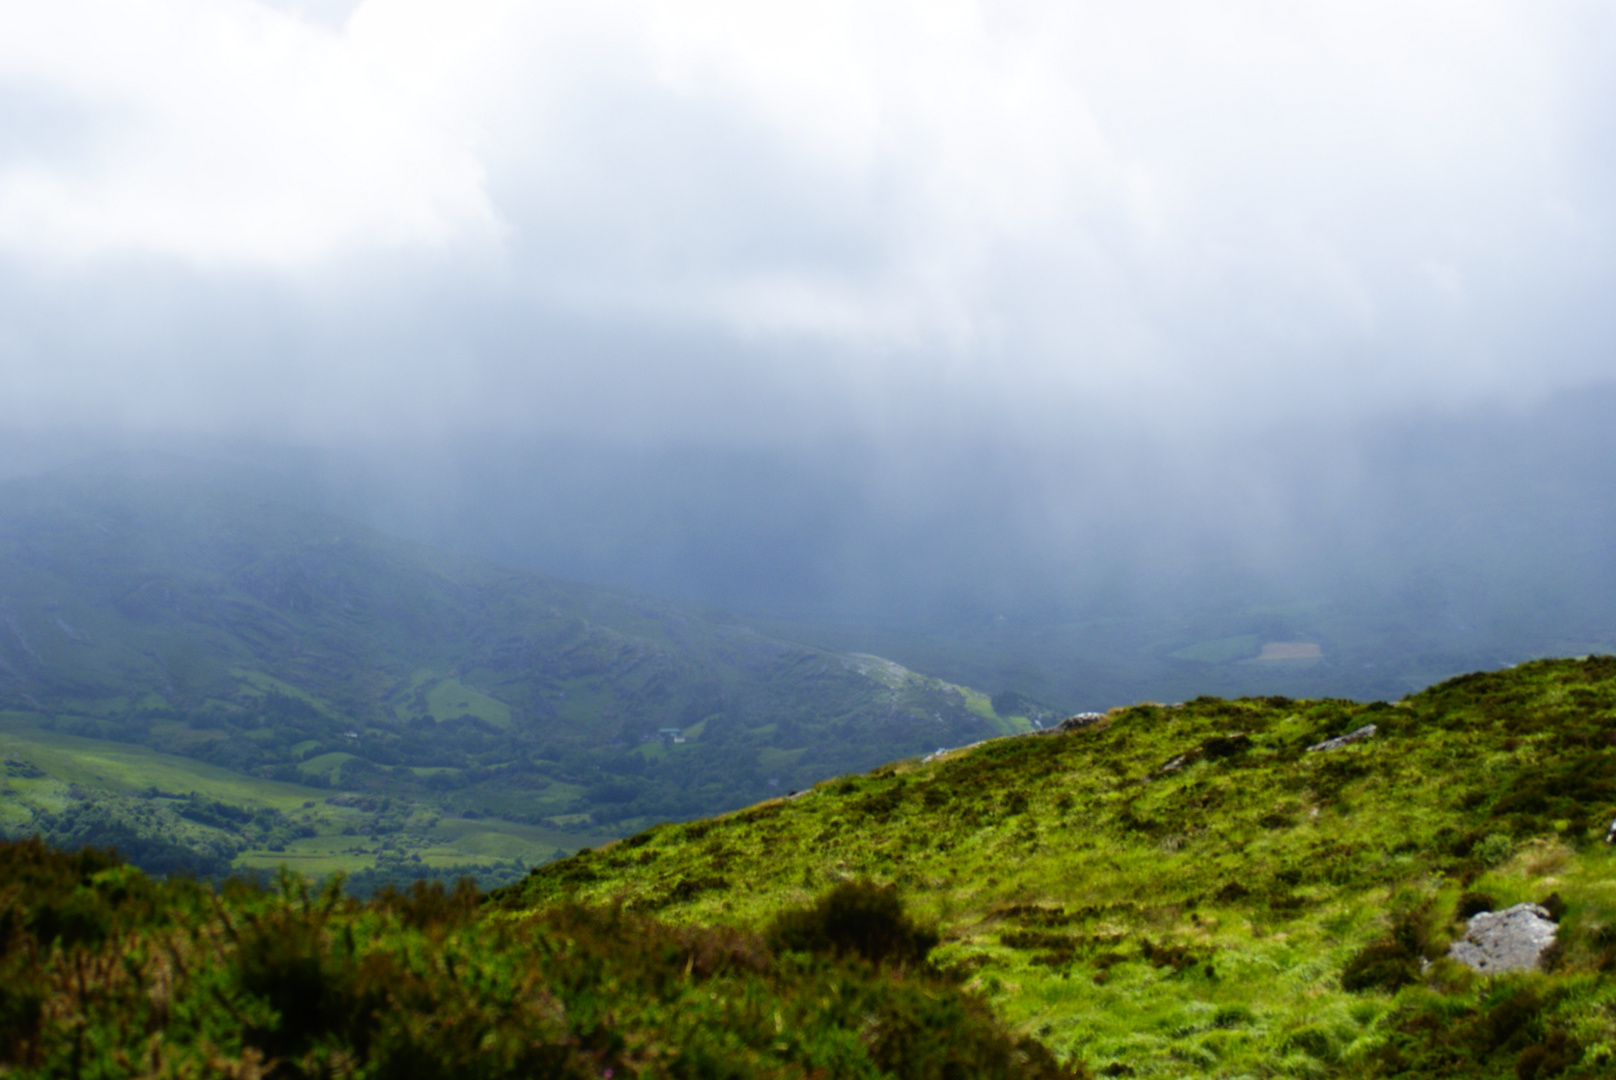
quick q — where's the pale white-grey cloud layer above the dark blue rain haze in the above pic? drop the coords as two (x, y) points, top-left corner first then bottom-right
(0, 0), (1616, 435)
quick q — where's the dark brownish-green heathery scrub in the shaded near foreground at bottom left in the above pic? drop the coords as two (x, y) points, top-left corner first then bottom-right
(0, 841), (1086, 1080)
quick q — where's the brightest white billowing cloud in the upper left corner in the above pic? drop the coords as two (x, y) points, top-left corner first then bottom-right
(0, 0), (493, 267)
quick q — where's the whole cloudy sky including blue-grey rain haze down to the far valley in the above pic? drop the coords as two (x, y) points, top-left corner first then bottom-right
(0, 0), (1616, 649)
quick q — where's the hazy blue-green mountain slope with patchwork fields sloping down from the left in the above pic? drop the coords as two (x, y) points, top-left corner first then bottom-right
(0, 474), (1044, 873)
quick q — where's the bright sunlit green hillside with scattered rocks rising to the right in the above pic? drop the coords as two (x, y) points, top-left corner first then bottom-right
(498, 658), (1616, 1078)
